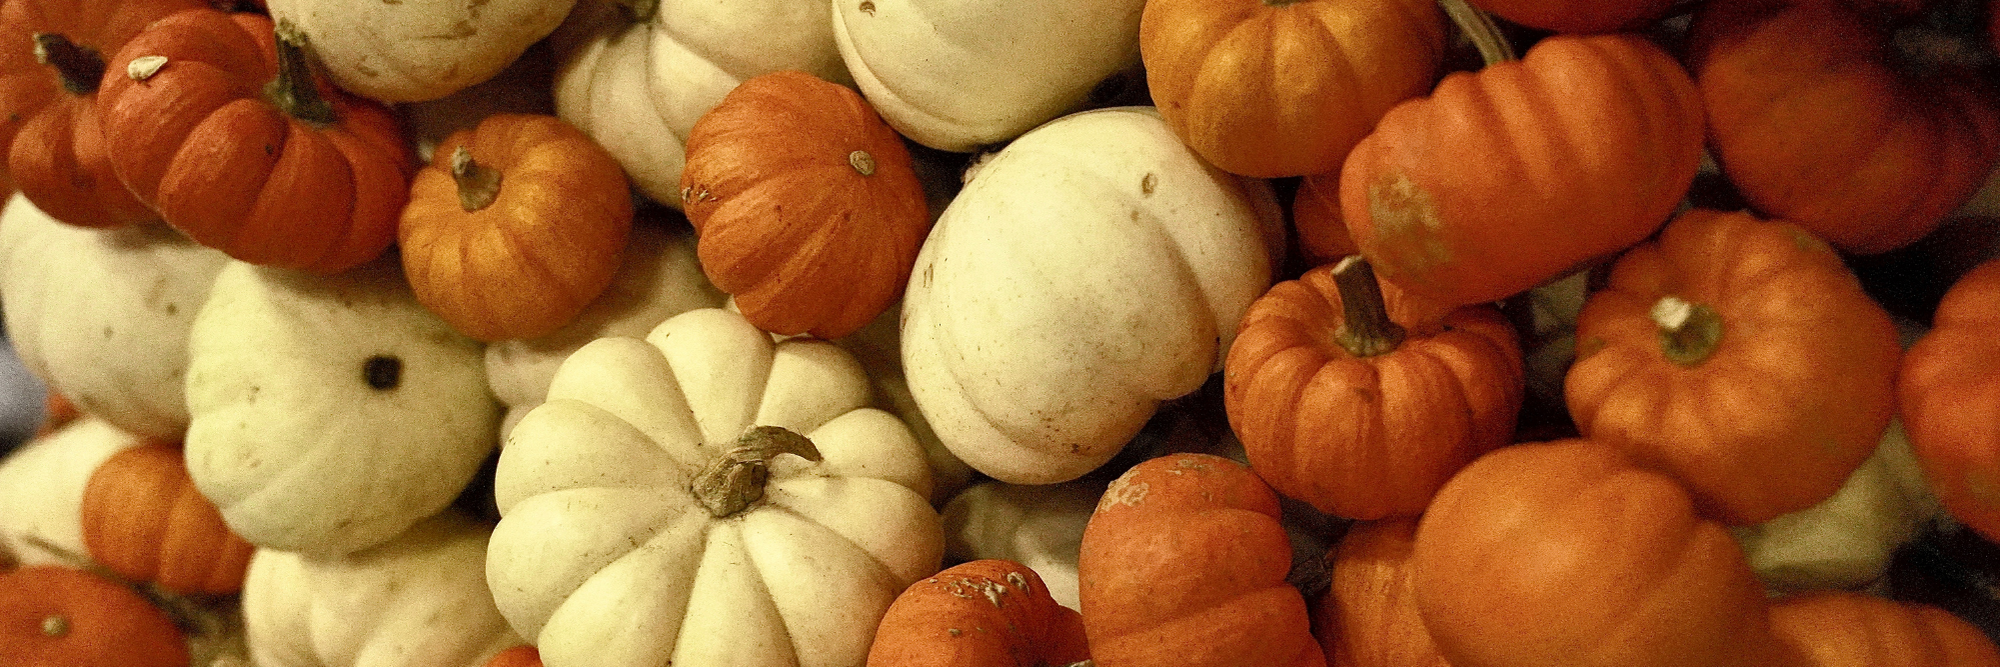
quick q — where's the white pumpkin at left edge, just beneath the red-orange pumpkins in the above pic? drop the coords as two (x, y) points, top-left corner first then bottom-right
(0, 194), (228, 439)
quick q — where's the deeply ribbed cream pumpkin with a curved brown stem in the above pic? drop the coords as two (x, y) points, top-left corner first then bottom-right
(486, 308), (944, 667)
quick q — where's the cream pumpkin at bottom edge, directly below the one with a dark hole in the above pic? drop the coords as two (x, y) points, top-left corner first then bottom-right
(242, 511), (522, 667)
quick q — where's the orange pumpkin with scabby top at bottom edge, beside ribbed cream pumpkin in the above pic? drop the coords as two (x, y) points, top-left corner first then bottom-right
(868, 559), (1090, 667)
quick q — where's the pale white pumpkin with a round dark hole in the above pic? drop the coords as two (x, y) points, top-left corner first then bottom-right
(186, 254), (500, 555)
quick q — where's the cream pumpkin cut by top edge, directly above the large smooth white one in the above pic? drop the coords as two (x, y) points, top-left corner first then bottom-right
(834, 0), (1146, 152)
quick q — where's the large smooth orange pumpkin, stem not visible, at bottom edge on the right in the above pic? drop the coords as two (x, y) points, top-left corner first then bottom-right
(1412, 439), (1782, 667)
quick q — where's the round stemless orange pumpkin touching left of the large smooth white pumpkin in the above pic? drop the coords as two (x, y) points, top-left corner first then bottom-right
(680, 70), (930, 339)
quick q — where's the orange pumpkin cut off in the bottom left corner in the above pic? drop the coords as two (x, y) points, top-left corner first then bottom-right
(0, 565), (188, 667)
